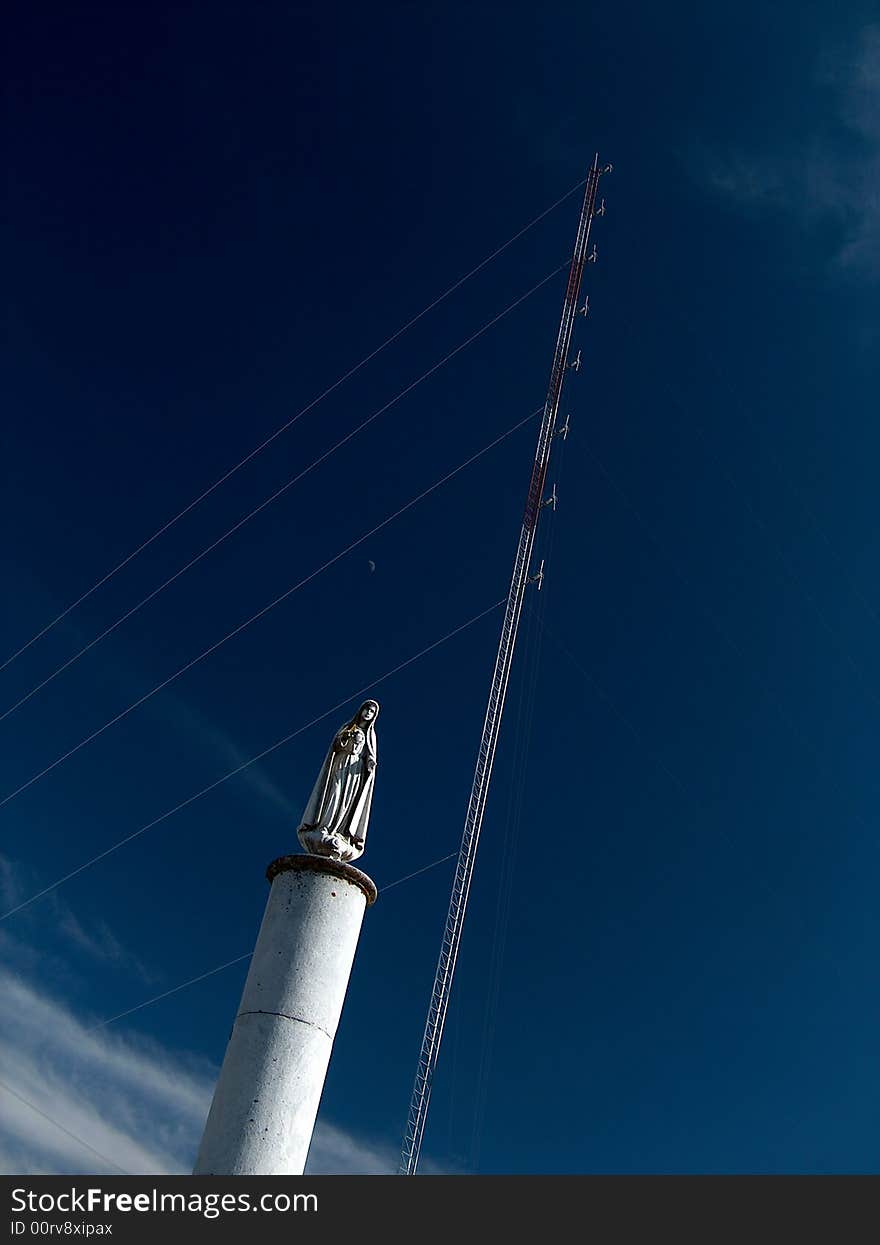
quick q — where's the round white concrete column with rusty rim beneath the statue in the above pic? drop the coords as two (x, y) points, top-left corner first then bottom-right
(193, 855), (376, 1175)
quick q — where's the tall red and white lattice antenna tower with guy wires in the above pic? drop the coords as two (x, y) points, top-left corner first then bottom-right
(398, 154), (611, 1175)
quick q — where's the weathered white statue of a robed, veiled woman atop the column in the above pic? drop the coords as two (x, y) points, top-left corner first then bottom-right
(296, 701), (378, 862)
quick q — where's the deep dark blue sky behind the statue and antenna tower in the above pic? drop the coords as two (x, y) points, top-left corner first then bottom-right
(0, 2), (880, 1173)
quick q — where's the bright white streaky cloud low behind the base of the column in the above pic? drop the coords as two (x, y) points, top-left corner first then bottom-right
(0, 969), (410, 1175)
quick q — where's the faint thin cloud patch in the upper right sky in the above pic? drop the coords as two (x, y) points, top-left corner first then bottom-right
(697, 25), (880, 278)
